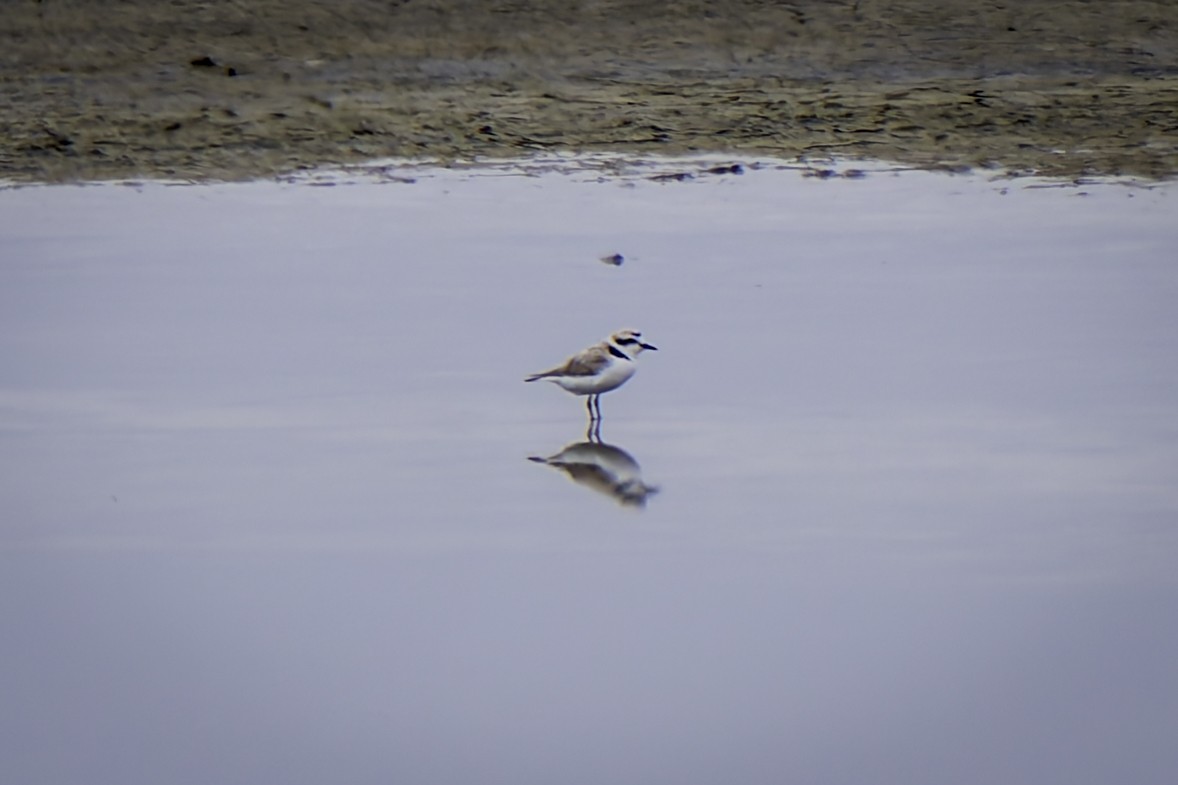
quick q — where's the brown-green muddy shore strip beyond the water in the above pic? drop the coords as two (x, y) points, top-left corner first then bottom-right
(0, 0), (1178, 182)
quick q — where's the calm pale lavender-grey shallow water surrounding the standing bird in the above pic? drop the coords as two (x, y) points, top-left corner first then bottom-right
(0, 161), (1178, 785)
